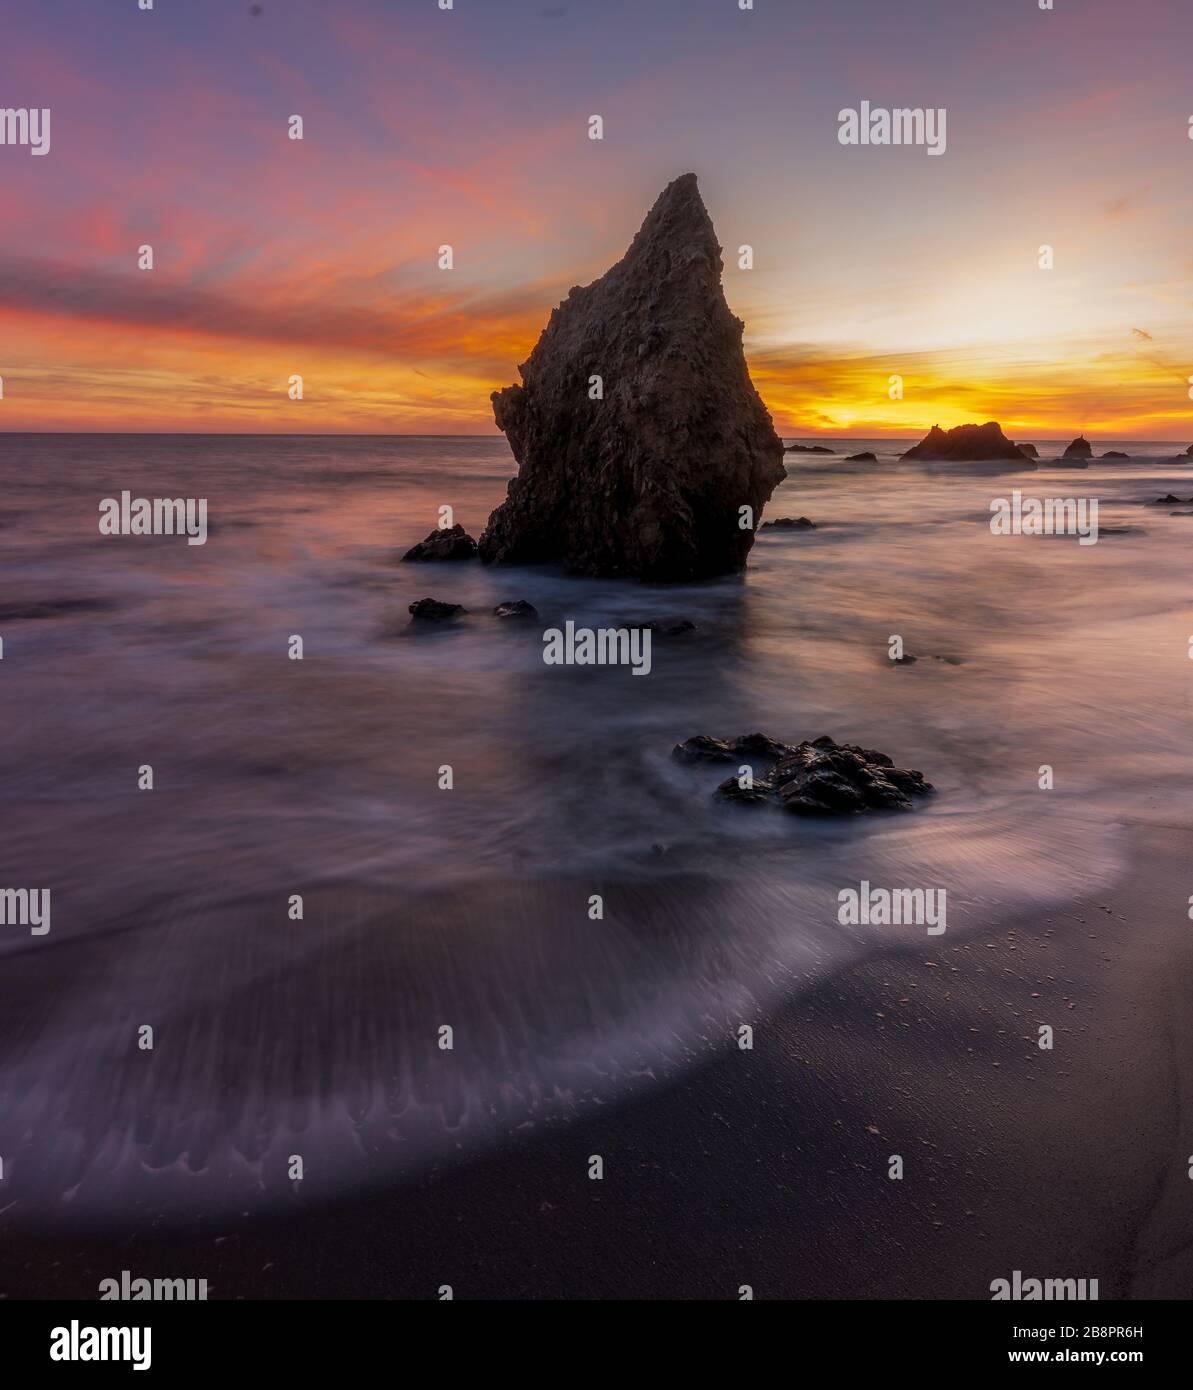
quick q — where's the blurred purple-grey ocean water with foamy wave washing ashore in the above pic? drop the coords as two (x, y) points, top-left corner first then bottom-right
(0, 435), (1193, 1226)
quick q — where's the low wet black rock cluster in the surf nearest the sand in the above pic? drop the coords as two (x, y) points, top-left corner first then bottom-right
(674, 734), (934, 816)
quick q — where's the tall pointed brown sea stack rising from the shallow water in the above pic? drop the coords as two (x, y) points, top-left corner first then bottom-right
(480, 174), (786, 581)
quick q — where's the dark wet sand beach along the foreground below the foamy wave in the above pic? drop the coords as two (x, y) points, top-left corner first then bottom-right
(0, 824), (1193, 1300)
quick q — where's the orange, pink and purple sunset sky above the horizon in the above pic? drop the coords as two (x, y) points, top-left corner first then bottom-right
(0, 0), (1193, 443)
